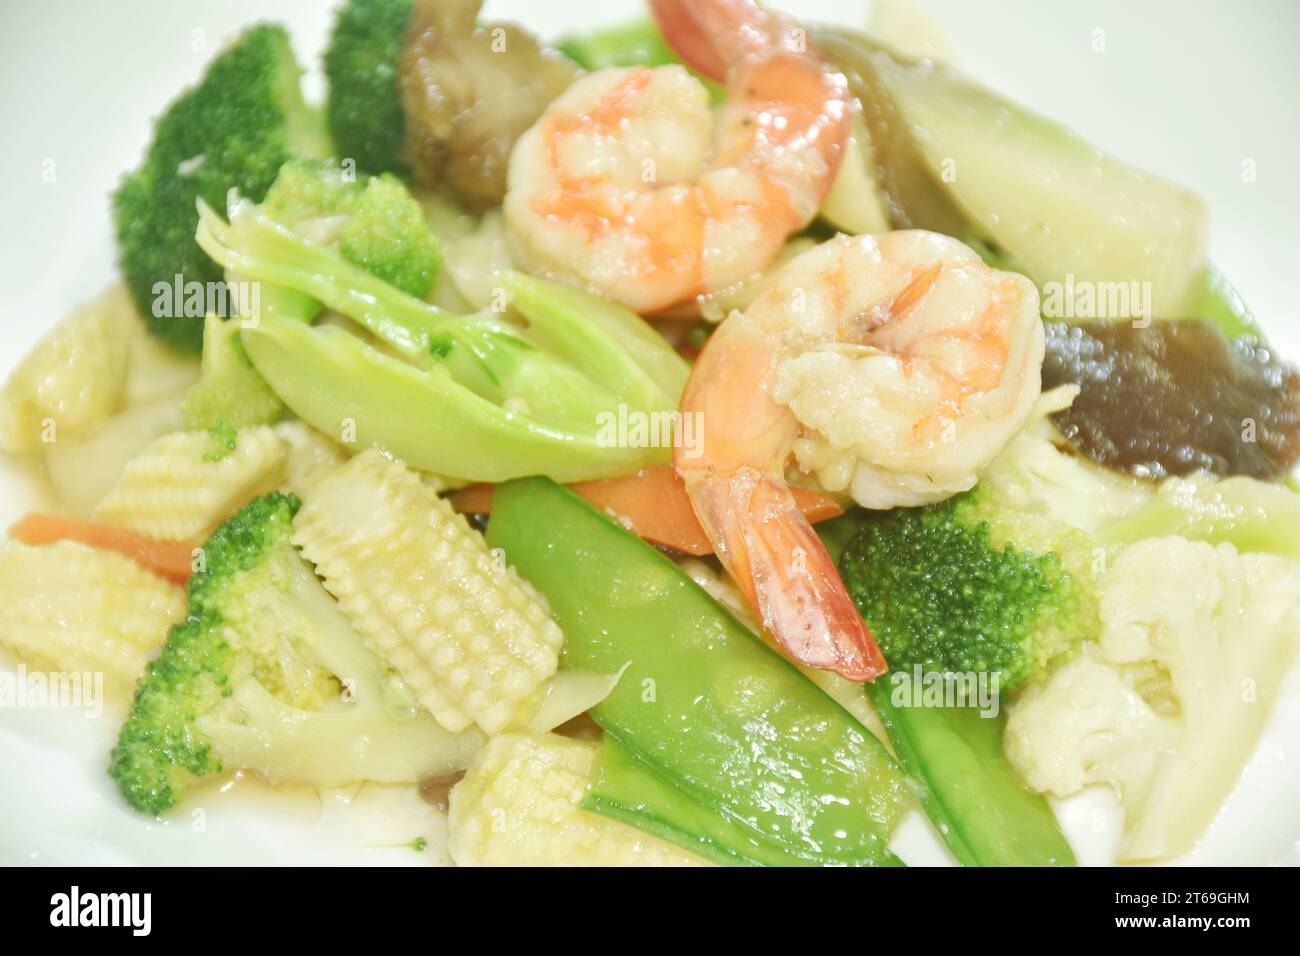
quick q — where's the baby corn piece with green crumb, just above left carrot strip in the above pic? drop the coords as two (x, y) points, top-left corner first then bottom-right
(95, 425), (285, 541)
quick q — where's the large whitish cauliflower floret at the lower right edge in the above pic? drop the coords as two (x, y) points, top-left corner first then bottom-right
(1006, 537), (1300, 860)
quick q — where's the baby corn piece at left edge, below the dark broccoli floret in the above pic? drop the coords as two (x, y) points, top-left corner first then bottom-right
(0, 285), (139, 454)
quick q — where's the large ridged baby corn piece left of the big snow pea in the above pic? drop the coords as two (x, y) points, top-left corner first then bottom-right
(294, 449), (563, 734)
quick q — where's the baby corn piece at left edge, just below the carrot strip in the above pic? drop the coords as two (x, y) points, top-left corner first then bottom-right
(0, 541), (185, 697)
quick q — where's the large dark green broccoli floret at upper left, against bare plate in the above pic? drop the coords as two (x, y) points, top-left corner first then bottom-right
(113, 23), (332, 351)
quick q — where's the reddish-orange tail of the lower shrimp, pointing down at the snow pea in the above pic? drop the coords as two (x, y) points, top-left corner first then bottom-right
(692, 468), (888, 682)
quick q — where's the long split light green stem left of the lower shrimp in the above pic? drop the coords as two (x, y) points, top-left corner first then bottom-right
(199, 184), (688, 481)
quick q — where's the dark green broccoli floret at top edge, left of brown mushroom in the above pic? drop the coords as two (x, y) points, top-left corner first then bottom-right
(325, 0), (413, 173)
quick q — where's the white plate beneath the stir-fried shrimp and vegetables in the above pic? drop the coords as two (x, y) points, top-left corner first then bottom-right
(0, 0), (1300, 864)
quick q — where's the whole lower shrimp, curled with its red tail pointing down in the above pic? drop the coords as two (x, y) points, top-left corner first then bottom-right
(673, 230), (1044, 680)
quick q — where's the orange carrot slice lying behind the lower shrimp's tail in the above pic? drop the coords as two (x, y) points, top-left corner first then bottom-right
(451, 464), (844, 555)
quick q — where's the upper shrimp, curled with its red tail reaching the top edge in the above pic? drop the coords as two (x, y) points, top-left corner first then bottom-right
(504, 0), (852, 313)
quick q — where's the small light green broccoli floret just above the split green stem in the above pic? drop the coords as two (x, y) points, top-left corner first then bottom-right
(261, 160), (442, 299)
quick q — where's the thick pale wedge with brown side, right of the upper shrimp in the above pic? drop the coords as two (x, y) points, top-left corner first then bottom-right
(811, 27), (1208, 319)
